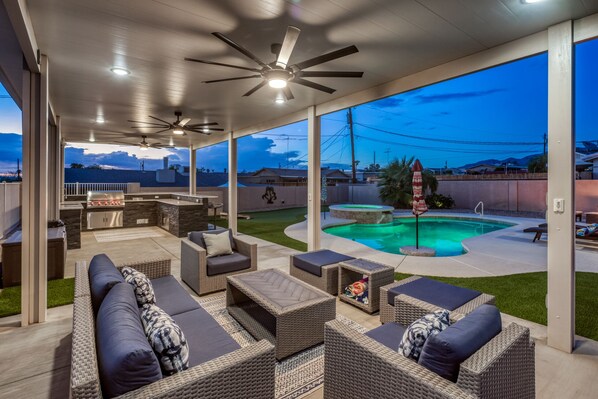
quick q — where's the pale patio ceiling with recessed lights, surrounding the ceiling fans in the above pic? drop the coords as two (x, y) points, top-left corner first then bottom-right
(27, 0), (598, 146)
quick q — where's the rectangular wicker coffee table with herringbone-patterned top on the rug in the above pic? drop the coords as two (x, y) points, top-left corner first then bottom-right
(226, 270), (336, 360)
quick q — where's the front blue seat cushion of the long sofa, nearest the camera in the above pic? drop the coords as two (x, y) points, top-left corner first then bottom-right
(172, 307), (241, 367)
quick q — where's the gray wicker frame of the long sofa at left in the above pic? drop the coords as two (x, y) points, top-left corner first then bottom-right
(70, 259), (275, 399)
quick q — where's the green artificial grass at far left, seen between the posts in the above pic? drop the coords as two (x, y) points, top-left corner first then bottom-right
(0, 278), (75, 317)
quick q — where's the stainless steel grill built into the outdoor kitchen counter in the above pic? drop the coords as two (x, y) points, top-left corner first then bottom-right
(87, 191), (125, 230)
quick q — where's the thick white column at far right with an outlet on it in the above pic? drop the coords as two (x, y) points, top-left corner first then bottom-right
(547, 21), (575, 352)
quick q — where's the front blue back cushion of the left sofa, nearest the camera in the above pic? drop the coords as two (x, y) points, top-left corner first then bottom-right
(96, 282), (162, 398)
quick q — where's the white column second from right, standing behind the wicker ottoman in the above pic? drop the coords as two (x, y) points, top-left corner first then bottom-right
(307, 106), (322, 251)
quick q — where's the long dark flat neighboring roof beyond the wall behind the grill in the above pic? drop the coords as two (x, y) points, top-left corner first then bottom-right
(64, 168), (228, 187)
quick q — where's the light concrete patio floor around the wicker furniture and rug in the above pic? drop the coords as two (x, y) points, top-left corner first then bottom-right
(0, 228), (598, 399)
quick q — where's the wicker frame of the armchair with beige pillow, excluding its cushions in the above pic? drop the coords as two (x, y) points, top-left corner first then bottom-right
(181, 233), (257, 295)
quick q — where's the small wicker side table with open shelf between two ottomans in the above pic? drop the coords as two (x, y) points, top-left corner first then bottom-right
(338, 259), (395, 313)
